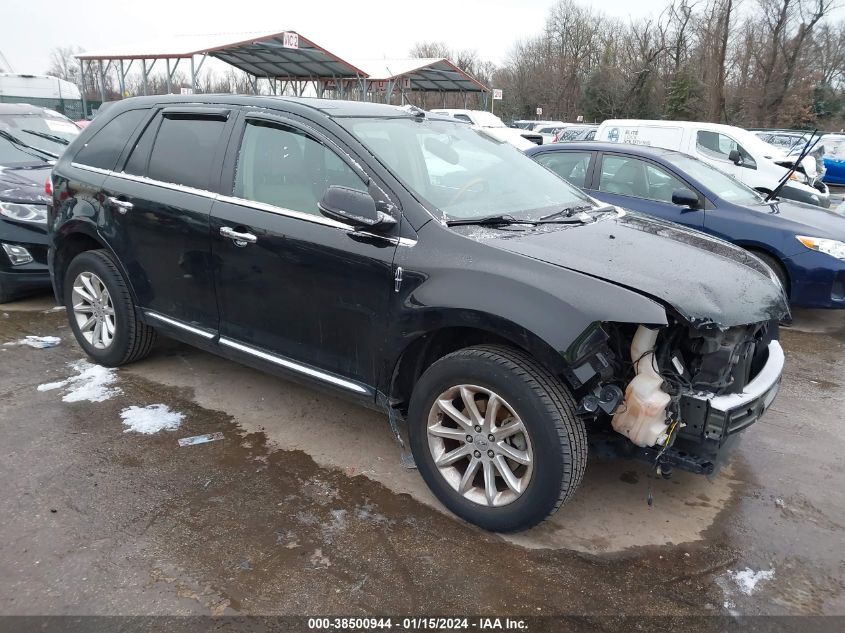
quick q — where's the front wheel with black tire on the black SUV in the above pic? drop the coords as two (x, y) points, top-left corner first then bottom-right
(408, 345), (587, 532)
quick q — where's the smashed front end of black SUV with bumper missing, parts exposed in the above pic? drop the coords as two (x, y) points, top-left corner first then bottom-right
(566, 316), (784, 476)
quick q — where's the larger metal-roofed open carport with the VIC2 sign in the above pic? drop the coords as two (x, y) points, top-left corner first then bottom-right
(76, 31), (367, 112)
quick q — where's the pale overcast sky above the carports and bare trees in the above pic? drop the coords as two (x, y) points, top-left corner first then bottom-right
(0, 0), (845, 74)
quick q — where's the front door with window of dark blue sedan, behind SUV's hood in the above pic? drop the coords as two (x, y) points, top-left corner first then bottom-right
(589, 152), (704, 229)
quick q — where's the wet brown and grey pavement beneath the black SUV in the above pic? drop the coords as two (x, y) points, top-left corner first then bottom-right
(0, 298), (845, 615)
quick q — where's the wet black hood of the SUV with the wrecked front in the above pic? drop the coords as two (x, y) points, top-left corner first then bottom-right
(458, 212), (789, 328)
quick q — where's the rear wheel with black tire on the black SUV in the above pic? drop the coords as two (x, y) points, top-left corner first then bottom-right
(64, 250), (156, 367)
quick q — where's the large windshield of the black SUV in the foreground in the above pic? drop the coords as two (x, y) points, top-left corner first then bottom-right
(340, 118), (594, 220)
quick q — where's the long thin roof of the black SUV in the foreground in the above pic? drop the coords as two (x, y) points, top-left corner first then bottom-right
(99, 94), (438, 118)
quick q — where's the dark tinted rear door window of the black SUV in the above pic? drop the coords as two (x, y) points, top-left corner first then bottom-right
(148, 116), (226, 189)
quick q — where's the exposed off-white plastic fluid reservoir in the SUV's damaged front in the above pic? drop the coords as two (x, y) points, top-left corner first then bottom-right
(612, 325), (670, 446)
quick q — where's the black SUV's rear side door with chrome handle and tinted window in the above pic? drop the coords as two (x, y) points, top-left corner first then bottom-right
(103, 106), (232, 338)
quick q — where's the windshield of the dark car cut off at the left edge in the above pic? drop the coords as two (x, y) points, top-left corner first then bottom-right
(0, 112), (80, 162)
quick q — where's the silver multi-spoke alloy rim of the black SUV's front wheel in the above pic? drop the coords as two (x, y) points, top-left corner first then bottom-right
(427, 385), (534, 507)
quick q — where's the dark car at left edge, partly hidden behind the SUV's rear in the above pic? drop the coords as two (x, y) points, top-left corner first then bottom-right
(0, 103), (79, 303)
